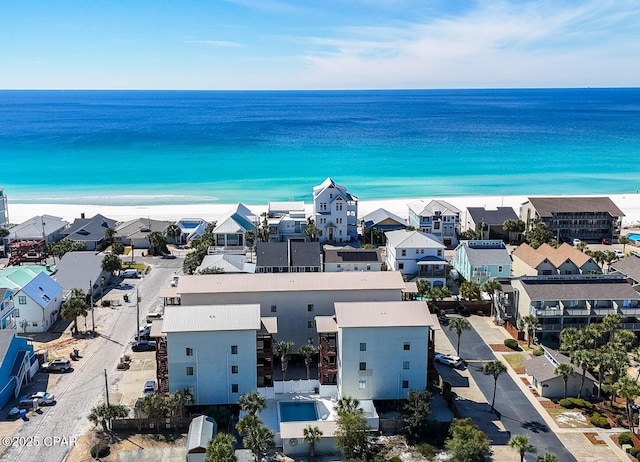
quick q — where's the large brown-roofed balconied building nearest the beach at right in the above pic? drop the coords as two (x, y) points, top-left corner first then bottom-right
(520, 197), (624, 242)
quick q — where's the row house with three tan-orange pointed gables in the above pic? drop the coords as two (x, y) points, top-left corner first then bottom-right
(512, 243), (602, 276)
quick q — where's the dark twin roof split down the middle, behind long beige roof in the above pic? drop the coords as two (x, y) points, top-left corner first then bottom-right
(256, 241), (322, 268)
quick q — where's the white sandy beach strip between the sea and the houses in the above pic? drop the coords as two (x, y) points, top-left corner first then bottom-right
(9, 193), (640, 227)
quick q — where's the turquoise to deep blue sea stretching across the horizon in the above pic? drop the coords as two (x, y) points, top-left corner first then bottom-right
(0, 89), (640, 205)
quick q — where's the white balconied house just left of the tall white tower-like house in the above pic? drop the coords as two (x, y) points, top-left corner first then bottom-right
(267, 201), (307, 242)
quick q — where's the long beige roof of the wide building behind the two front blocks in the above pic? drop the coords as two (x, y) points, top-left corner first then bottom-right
(176, 271), (405, 294)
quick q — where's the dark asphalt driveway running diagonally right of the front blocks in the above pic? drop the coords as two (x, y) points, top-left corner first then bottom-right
(443, 328), (576, 462)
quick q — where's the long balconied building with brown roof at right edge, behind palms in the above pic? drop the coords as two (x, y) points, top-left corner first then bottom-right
(511, 274), (640, 343)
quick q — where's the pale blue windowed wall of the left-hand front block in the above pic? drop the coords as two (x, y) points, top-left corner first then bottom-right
(167, 330), (257, 404)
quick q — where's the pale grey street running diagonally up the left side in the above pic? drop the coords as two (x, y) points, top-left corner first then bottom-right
(0, 258), (183, 462)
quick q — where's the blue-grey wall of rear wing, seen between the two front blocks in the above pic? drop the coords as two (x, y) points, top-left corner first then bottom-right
(182, 288), (402, 351)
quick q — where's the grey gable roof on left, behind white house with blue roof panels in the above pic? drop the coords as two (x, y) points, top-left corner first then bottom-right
(52, 251), (104, 293)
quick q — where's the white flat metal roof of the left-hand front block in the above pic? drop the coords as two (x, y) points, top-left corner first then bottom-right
(162, 304), (261, 333)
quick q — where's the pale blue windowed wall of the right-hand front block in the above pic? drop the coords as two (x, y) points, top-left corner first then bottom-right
(338, 327), (429, 399)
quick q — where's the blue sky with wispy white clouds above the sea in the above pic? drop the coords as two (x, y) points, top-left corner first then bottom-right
(0, 0), (640, 90)
